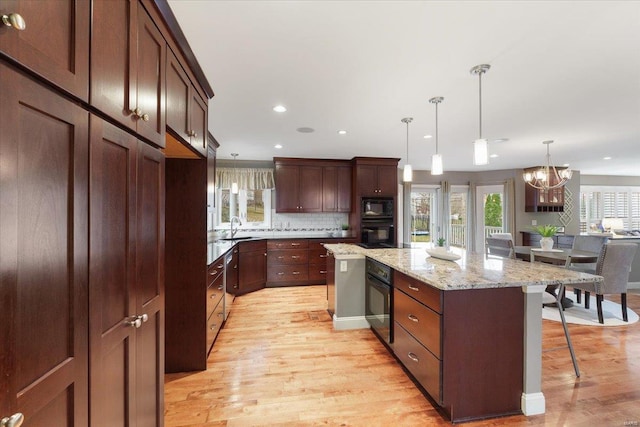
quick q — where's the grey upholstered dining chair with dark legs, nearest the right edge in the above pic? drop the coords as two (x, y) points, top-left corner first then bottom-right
(572, 242), (638, 324)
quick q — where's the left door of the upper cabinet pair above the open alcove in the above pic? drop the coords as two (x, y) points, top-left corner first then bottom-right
(166, 50), (191, 141)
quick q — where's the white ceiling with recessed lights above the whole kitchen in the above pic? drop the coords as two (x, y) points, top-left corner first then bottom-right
(169, 0), (640, 176)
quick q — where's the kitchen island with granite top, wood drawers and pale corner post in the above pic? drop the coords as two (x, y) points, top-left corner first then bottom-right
(325, 245), (602, 422)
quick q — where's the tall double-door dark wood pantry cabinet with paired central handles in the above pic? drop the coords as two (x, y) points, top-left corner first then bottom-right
(89, 116), (165, 425)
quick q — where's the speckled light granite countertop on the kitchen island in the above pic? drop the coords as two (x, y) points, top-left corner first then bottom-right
(325, 244), (603, 291)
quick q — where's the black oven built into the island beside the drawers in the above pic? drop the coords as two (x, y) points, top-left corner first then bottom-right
(365, 258), (393, 344)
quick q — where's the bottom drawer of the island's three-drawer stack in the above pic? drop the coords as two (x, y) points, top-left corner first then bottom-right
(393, 322), (442, 404)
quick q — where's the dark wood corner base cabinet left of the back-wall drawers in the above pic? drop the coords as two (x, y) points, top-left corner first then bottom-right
(237, 240), (267, 295)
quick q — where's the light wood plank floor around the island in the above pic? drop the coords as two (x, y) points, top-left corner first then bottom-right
(165, 286), (640, 427)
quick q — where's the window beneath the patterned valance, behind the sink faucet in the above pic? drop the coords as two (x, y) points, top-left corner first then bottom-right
(217, 188), (271, 228)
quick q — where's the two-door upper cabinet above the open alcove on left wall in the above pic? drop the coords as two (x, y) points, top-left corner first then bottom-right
(166, 50), (207, 156)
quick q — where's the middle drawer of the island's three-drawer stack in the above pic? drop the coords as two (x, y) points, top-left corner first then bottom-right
(393, 289), (442, 359)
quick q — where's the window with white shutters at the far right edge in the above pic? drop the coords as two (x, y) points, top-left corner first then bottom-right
(580, 185), (640, 233)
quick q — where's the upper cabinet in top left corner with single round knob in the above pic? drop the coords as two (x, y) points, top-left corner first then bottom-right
(0, 0), (91, 101)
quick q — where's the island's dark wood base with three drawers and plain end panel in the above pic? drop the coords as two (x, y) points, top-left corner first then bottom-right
(392, 271), (524, 422)
